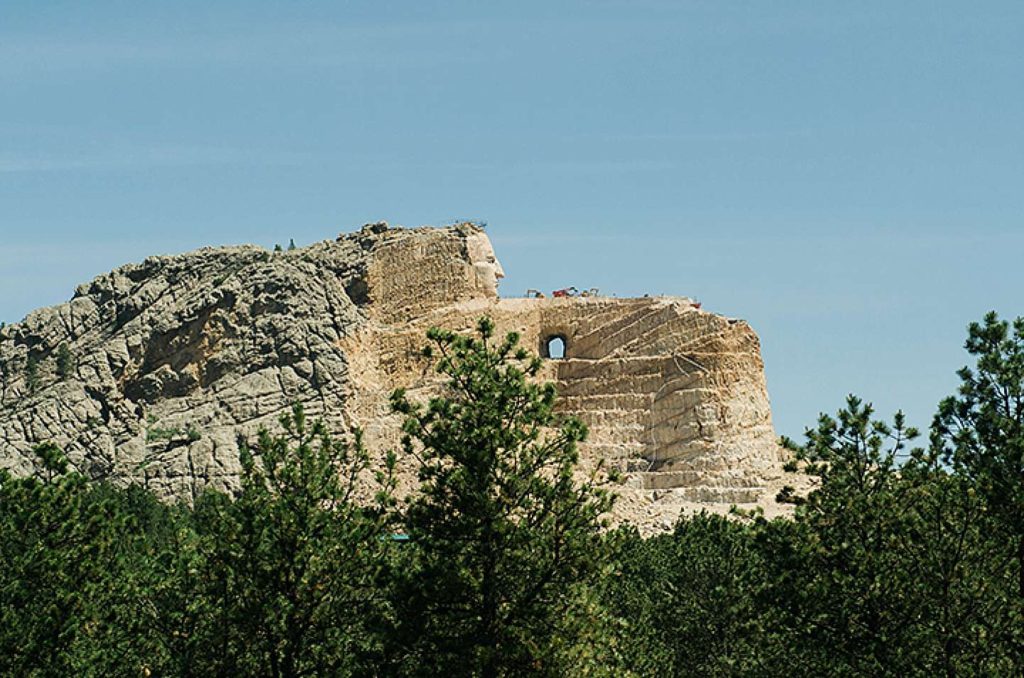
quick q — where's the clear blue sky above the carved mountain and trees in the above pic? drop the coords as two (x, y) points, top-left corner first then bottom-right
(0, 0), (1024, 435)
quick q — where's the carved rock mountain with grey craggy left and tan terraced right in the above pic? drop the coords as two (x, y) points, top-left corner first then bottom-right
(0, 224), (782, 527)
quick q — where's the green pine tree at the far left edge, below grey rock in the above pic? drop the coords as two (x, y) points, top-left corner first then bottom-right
(0, 443), (146, 676)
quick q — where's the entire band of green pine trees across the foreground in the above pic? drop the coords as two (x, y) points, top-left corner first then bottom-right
(0, 313), (1024, 677)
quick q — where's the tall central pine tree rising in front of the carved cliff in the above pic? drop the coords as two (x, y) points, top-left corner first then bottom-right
(392, 319), (612, 676)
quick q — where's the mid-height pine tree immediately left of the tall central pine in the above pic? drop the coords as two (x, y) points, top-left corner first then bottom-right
(196, 406), (392, 676)
